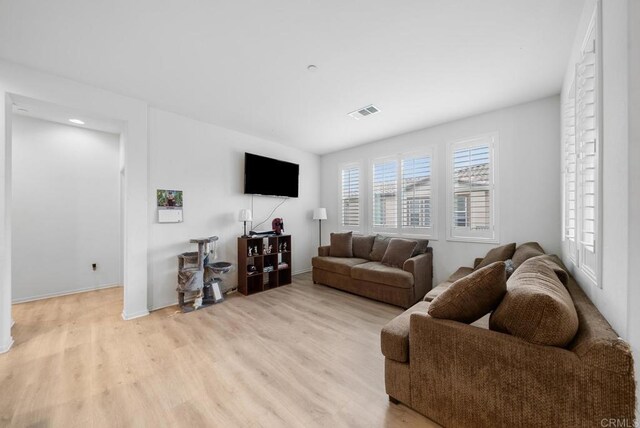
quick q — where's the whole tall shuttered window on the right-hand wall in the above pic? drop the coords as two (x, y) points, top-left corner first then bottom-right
(563, 2), (601, 285)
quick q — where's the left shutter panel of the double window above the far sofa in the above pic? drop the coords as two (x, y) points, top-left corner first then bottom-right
(372, 159), (398, 231)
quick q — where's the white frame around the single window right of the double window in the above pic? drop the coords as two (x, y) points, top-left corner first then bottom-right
(446, 131), (500, 244)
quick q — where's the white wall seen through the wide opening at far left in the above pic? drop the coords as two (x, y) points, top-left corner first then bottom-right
(12, 116), (122, 302)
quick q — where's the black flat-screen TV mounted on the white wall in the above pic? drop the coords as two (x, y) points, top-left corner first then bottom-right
(244, 153), (300, 198)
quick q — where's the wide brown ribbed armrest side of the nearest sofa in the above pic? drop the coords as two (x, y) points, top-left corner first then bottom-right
(409, 314), (635, 426)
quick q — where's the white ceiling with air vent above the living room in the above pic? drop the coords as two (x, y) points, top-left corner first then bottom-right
(0, 0), (584, 154)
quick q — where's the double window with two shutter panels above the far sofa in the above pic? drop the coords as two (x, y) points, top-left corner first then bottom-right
(371, 153), (435, 238)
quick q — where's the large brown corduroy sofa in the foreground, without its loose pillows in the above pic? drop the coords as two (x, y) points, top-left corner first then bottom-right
(381, 247), (635, 427)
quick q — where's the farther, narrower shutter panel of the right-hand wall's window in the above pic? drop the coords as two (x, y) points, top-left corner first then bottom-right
(562, 83), (578, 261)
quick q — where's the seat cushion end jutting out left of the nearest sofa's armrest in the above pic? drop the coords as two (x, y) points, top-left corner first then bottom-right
(380, 302), (429, 363)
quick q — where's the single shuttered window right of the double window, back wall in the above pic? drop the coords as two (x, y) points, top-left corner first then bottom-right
(447, 134), (498, 242)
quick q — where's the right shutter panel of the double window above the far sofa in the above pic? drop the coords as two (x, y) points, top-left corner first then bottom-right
(400, 155), (432, 229)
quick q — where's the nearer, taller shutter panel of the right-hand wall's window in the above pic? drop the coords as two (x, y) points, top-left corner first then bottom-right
(575, 20), (600, 280)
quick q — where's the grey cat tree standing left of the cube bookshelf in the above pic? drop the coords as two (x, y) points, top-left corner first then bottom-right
(176, 236), (232, 312)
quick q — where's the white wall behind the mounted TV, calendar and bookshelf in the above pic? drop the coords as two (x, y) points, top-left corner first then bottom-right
(149, 108), (320, 308)
